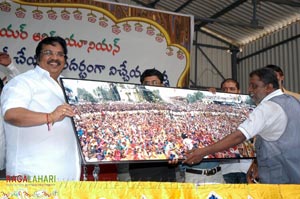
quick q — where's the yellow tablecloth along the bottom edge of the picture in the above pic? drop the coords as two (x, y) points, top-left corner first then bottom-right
(0, 181), (300, 199)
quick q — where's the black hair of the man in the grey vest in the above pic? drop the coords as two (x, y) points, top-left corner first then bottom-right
(249, 67), (279, 89)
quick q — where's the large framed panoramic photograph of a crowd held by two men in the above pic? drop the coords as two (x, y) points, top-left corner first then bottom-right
(61, 78), (255, 164)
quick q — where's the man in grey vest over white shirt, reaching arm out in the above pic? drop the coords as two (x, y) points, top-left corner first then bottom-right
(183, 68), (300, 184)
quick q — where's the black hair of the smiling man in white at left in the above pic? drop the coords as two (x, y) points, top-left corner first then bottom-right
(34, 36), (68, 62)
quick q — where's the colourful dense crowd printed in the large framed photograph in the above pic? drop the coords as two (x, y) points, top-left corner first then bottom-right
(74, 97), (253, 162)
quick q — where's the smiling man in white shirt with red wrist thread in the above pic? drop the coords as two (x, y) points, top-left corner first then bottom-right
(1, 37), (80, 181)
